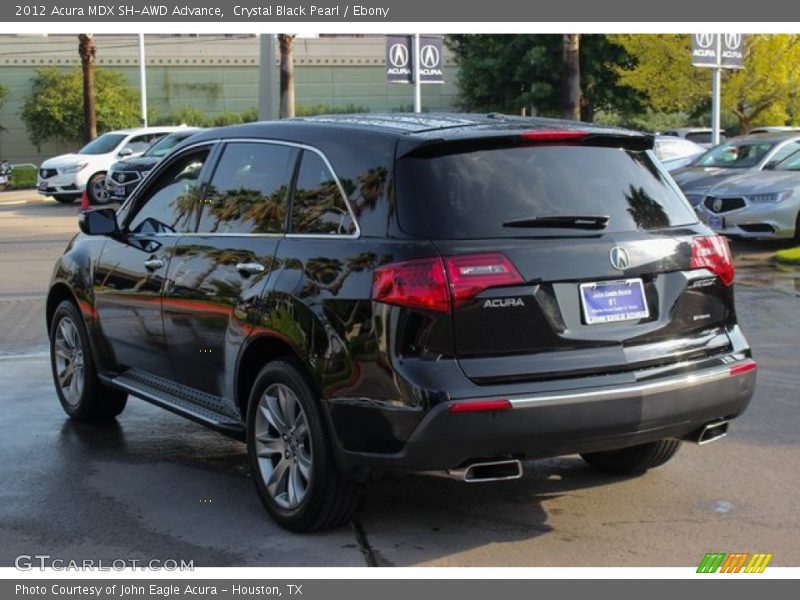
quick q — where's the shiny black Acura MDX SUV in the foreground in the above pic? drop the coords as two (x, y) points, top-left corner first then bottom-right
(47, 114), (756, 531)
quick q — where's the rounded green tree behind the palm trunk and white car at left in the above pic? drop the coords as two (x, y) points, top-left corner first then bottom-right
(20, 68), (139, 146)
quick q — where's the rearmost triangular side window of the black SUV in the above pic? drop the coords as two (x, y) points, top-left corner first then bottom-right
(292, 150), (356, 234)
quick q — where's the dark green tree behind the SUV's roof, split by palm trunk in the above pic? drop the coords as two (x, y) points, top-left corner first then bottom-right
(446, 34), (643, 121)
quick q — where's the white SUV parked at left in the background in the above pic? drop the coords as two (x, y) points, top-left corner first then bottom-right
(37, 127), (188, 204)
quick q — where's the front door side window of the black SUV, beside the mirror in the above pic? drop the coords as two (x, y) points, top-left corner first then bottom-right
(128, 148), (210, 234)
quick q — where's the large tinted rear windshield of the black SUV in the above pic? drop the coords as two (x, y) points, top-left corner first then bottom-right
(397, 146), (697, 239)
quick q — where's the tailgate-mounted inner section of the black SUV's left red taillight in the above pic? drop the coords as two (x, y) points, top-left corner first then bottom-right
(444, 252), (524, 308)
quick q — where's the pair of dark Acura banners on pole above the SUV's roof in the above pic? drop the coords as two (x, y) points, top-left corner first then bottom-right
(386, 35), (444, 83)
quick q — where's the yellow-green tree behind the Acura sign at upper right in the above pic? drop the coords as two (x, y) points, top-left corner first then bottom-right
(610, 34), (800, 133)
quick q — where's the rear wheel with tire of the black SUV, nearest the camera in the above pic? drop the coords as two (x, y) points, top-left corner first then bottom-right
(247, 359), (363, 532)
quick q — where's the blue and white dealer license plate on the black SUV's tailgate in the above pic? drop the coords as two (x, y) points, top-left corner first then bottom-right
(580, 278), (650, 325)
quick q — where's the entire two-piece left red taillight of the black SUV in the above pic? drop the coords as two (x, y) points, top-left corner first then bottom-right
(372, 253), (524, 312)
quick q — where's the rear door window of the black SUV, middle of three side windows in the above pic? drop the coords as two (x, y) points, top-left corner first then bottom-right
(198, 142), (299, 233)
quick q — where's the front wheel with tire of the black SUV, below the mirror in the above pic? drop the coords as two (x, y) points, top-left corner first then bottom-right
(50, 300), (128, 421)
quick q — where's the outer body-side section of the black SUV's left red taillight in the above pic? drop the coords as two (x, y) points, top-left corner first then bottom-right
(372, 256), (450, 312)
